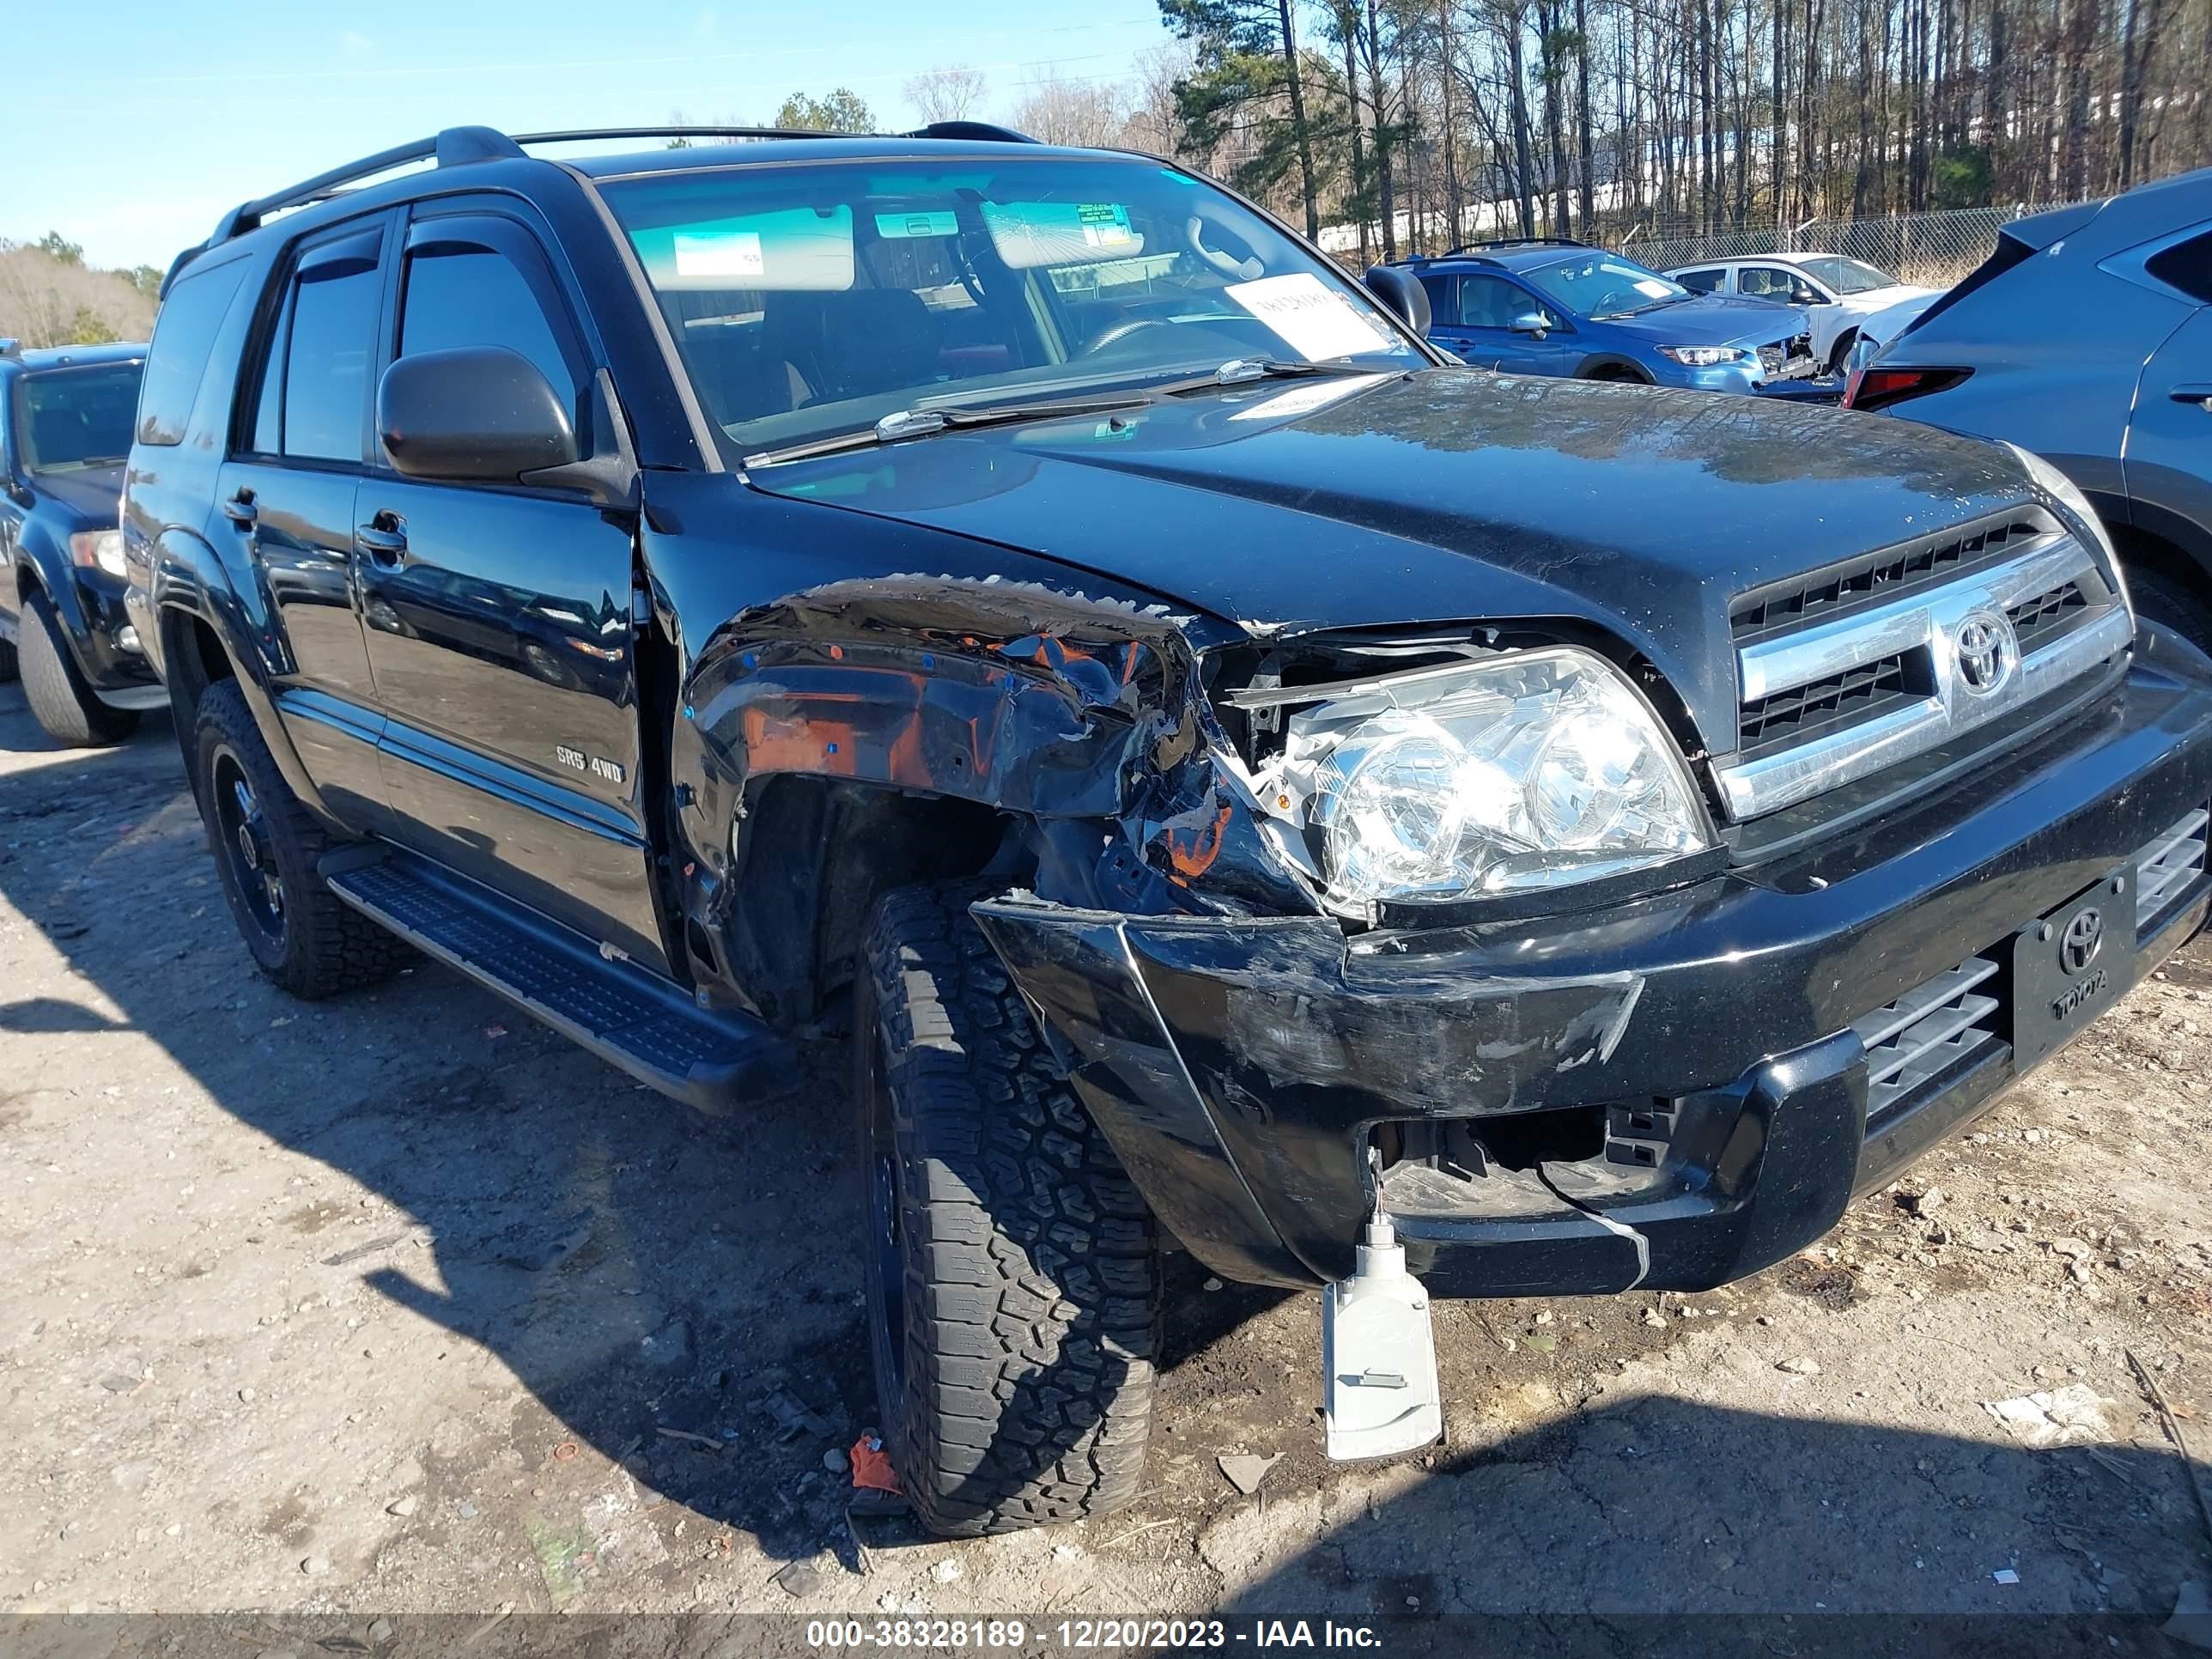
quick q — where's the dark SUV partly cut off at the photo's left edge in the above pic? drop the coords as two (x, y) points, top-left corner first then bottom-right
(0, 341), (168, 748)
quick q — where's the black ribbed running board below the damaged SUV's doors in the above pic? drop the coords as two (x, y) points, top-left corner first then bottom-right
(321, 848), (792, 1113)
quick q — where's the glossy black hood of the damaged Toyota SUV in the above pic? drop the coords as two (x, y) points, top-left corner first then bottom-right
(748, 369), (2028, 752)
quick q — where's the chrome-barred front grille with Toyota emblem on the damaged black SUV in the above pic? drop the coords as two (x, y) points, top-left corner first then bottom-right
(1714, 507), (2135, 823)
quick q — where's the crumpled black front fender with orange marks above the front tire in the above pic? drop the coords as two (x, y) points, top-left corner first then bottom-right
(671, 575), (1312, 1026)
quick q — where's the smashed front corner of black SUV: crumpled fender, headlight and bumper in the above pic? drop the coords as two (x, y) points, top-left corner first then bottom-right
(646, 500), (2212, 1297)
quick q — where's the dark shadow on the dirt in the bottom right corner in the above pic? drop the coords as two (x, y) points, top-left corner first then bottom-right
(1201, 1398), (2212, 1627)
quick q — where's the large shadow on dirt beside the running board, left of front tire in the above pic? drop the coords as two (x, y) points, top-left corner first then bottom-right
(0, 688), (1276, 1583)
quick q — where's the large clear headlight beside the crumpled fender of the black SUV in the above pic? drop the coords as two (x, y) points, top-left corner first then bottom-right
(1237, 648), (1712, 918)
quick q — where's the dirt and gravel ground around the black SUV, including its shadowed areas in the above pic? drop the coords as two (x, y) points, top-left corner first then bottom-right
(0, 686), (2212, 1627)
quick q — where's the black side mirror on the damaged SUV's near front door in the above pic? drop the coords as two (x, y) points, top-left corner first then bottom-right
(376, 345), (577, 484)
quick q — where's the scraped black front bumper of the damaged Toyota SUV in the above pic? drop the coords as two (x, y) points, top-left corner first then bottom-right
(975, 635), (2212, 1297)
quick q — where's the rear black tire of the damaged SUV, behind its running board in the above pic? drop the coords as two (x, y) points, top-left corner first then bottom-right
(192, 679), (407, 1002)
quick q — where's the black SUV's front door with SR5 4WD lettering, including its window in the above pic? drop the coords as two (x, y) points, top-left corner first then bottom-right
(354, 204), (665, 967)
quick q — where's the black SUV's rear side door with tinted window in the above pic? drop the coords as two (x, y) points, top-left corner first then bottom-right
(220, 212), (398, 830)
